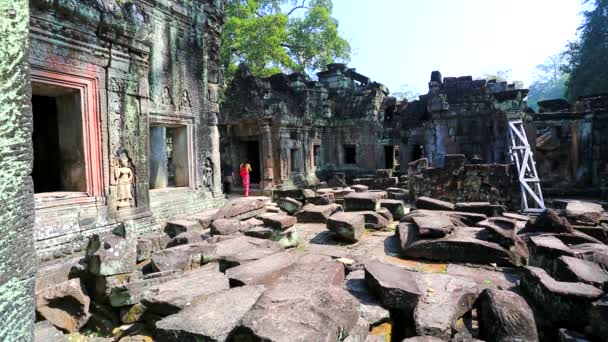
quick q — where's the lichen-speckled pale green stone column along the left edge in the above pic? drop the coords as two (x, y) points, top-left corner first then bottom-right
(0, 0), (36, 341)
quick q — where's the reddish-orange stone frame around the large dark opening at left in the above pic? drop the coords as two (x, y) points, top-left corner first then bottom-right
(31, 66), (104, 197)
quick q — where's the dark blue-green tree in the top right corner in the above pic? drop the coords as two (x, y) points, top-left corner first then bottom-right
(563, 0), (608, 100)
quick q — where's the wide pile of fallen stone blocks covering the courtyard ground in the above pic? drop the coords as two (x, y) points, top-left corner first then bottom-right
(36, 192), (608, 342)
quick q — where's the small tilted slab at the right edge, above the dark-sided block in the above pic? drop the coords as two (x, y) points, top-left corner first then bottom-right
(552, 256), (608, 289)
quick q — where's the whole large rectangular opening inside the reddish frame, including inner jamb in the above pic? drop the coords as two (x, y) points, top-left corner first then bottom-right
(32, 81), (87, 193)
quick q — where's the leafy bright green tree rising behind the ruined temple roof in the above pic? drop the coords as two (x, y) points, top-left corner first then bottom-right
(221, 0), (350, 79)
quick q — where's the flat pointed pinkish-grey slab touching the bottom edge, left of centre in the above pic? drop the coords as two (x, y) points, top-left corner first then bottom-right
(156, 286), (264, 341)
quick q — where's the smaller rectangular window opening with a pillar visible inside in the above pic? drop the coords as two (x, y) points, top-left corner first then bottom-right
(150, 125), (190, 190)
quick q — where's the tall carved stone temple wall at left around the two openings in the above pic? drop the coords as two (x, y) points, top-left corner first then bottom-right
(29, 0), (224, 259)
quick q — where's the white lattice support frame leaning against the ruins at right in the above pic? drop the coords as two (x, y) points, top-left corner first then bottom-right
(509, 120), (546, 213)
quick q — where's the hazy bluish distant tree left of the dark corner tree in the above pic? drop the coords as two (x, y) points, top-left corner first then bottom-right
(528, 53), (569, 111)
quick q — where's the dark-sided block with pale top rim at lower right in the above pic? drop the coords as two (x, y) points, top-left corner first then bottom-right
(521, 266), (602, 327)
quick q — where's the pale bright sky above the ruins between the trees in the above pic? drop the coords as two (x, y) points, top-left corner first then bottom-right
(333, 0), (583, 93)
